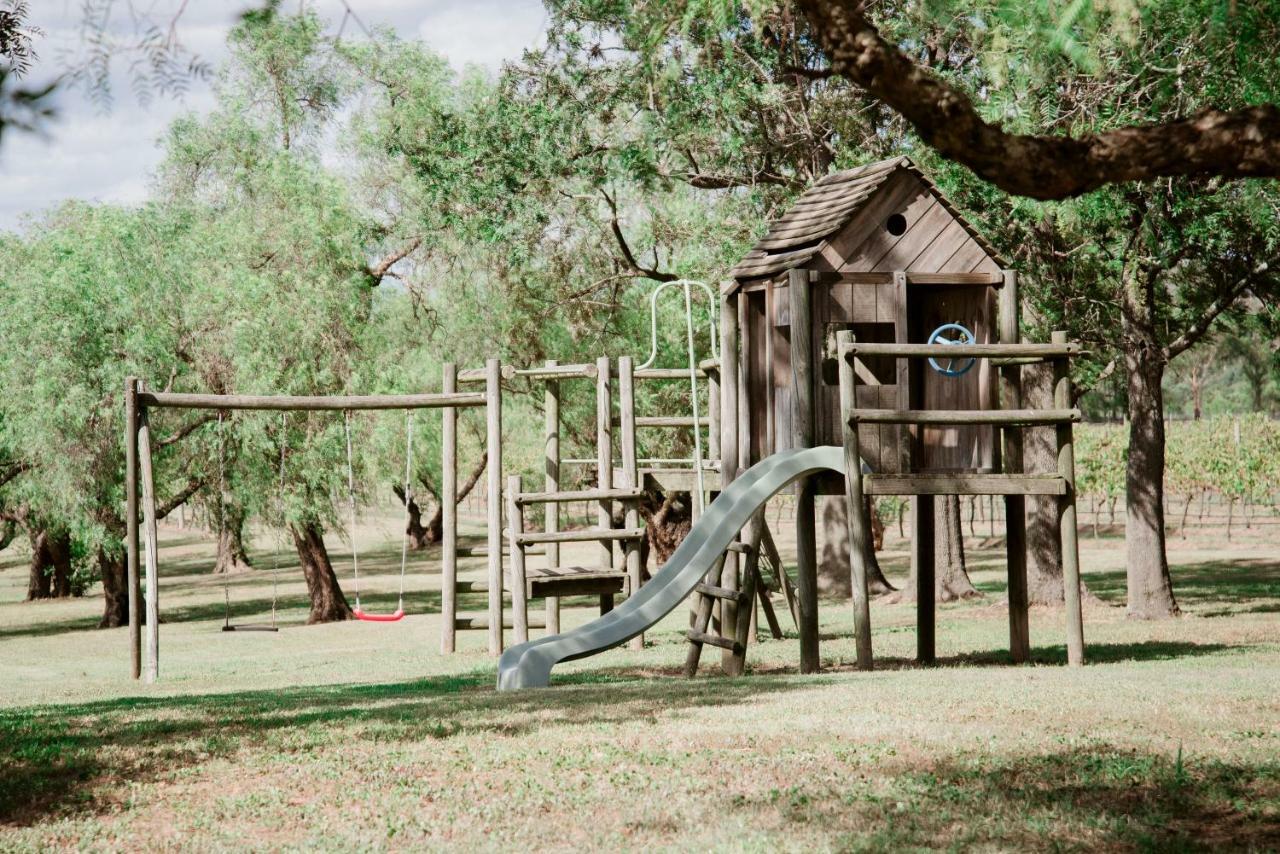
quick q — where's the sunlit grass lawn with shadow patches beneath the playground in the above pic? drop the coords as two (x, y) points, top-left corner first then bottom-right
(0, 507), (1280, 850)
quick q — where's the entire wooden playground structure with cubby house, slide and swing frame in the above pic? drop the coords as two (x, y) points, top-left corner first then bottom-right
(125, 157), (1084, 688)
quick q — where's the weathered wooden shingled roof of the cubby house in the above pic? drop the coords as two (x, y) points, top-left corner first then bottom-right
(730, 156), (998, 279)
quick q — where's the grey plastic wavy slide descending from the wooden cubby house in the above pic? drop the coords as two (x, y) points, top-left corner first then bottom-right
(498, 447), (845, 691)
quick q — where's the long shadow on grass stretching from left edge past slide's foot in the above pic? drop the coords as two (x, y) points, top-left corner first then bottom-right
(0, 670), (801, 826)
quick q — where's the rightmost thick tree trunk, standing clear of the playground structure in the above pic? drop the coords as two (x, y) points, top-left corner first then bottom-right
(1123, 282), (1178, 620)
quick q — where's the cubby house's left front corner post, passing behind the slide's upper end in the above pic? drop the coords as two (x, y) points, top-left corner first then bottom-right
(787, 269), (820, 673)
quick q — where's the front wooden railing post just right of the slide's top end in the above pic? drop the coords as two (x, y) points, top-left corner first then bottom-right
(836, 332), (872, 670)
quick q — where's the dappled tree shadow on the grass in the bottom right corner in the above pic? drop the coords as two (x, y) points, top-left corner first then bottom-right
(814, 743), (1280, 851)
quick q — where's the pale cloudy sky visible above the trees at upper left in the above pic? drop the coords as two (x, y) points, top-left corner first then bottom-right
(0, 0), (547, 229)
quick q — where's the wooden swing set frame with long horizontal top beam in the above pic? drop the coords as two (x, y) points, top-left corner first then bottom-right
(124, 371), (502, 682)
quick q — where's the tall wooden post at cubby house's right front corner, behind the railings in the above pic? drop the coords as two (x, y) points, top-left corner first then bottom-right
(1000, 270), (1032, 665)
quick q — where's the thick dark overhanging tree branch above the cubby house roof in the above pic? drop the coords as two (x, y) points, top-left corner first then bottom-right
(796, 0), (1280, 200)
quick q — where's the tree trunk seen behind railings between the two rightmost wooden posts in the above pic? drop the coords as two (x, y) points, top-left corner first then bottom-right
(1023, 364), (1064, 606)
